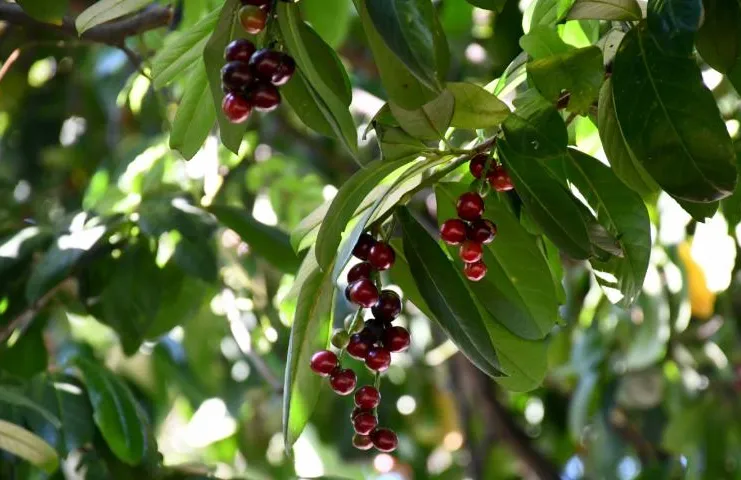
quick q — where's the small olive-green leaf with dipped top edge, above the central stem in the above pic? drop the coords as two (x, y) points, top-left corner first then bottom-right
(389, 90), (455, 140)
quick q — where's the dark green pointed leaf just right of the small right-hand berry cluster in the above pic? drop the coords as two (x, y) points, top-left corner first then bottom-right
(498, 141), (592, 259)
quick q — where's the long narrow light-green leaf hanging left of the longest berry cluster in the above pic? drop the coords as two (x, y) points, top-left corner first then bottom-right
(283, 268), (335, 451)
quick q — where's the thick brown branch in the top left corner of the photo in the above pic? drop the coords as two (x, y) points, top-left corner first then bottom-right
(0, 2), (173, 47)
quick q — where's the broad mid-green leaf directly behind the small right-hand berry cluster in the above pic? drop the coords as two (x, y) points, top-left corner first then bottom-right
(436, 183), (561, 340)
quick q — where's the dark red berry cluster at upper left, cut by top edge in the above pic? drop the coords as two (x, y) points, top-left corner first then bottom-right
(221, 0), (296, 123)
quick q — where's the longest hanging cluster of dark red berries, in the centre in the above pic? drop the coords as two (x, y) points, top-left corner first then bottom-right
(311, 233), (410, 452)
